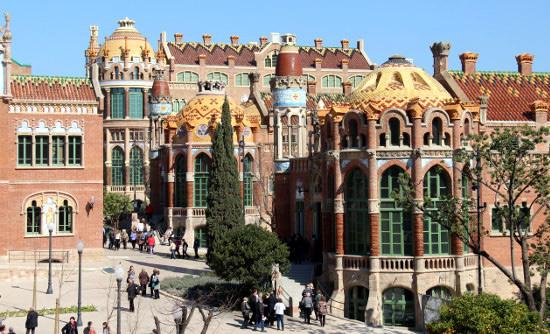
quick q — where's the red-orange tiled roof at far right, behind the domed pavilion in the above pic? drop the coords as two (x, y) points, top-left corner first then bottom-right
(449, 71), (550, 121)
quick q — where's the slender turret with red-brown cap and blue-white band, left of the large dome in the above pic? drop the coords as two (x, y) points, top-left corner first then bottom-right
(271, 34), (308, 172)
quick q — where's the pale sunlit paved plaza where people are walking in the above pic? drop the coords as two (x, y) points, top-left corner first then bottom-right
(0, 246), (418, 334)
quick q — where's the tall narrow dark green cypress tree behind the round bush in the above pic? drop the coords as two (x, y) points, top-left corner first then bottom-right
(206, 96), (244, 264)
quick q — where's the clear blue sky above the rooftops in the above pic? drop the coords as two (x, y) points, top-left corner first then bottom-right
(0, 0), (550, 76)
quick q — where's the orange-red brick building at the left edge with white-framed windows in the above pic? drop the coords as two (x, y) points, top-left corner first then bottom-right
(0, 16), (103, 261)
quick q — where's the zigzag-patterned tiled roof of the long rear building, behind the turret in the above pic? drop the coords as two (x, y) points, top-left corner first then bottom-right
(168, 42), (370, 70)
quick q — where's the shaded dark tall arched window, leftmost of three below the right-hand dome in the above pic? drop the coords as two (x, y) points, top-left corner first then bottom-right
(344, 168), (370, 255)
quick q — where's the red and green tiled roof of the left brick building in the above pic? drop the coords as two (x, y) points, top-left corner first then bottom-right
(11, 75), (96, 101)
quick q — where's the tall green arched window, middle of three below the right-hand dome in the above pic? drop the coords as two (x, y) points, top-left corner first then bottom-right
(380, 166), (413, 256)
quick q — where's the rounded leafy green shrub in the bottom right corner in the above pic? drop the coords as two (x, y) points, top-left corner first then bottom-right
(427, 294), (544, 334)
